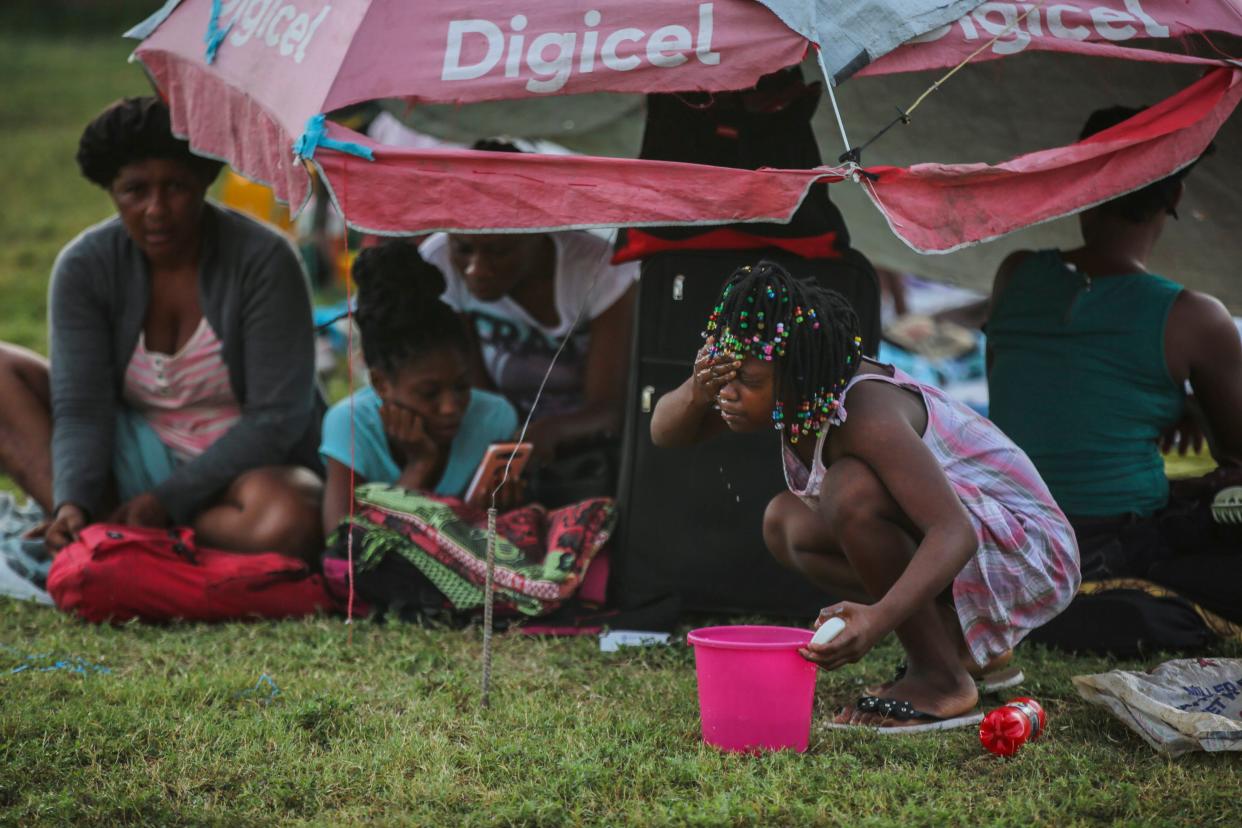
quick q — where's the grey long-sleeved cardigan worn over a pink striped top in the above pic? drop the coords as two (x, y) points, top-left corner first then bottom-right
(48, 202), (323, 524)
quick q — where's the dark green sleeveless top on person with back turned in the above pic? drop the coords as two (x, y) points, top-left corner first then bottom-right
(987, 251), (1185, 516)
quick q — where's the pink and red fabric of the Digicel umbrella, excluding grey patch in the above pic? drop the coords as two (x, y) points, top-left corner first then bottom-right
(137, 0), (1242, 252)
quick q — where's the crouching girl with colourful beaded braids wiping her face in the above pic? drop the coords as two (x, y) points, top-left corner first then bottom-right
(651, 262), (1079, 732)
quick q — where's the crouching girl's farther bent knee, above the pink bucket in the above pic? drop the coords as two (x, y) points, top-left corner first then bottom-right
(764, 492), (872, 603)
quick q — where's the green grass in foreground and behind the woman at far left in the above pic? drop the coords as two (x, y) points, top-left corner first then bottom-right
(0, 32), (1242, 826)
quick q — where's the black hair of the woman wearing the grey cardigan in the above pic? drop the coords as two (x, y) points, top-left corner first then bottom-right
(77, 96), (224, 190)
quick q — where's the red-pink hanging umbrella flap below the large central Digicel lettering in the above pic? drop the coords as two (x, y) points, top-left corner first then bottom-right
(317, 127), (841, 233)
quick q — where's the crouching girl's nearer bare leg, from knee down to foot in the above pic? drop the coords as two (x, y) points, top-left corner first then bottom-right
(821, 458), (979, 725)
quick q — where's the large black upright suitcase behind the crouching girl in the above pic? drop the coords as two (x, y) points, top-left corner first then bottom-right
(611, 248), (879, 618)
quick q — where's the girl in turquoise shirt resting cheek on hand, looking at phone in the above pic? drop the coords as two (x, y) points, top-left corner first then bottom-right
(319, 241), (520, 534)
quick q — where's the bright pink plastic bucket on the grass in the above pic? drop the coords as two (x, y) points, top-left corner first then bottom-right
(687, 627), (817, 752)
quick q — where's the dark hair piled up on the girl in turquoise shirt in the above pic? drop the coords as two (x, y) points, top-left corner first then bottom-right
(353, 240), (469, 376)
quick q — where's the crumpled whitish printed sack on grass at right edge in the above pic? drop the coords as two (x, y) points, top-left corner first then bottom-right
(1073, 658), (1242, 756)
